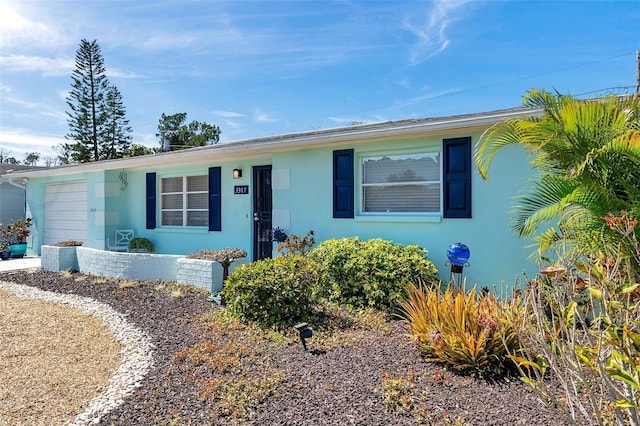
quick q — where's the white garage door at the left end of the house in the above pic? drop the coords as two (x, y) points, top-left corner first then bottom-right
(44, 182), (87, 244)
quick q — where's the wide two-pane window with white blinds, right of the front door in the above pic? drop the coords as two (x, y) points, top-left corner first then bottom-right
(361, 152), (442, 213)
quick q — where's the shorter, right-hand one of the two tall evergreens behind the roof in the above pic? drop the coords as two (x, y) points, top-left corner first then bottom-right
(99, 86), (132, 160)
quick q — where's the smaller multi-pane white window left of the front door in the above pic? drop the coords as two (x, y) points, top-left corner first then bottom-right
(160, 175), (209, 226)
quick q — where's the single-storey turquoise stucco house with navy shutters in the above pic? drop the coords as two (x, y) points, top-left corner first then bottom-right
(15, 108), (539, 286)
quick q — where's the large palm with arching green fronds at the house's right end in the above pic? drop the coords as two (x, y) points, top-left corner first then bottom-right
(474, 89), (640, 253)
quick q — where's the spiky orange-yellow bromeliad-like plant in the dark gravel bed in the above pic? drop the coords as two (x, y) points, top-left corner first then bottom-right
(401, 284), (524, 376)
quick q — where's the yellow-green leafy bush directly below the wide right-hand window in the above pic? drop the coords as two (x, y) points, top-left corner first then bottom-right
(309, 237), (437, 312)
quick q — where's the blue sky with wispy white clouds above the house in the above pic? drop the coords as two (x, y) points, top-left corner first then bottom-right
(0, 0), (640, 160)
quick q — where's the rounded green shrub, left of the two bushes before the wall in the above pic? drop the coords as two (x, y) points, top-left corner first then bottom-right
(222, 255), (321, 328)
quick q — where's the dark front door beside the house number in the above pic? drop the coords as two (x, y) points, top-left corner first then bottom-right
(253, 166), (273, 260)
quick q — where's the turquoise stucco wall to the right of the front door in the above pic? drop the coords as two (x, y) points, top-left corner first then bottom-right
(273, 134), (535, 287)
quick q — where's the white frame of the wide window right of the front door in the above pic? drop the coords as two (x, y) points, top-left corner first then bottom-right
(358, 151), (443, 217)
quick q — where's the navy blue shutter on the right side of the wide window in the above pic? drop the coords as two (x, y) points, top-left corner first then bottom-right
(442, 137), (471, 218)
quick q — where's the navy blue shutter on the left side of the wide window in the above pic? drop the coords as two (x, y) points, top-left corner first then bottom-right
(333, 149), (354, 219)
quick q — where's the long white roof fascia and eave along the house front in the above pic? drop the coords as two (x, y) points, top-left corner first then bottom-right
(11, 108), (542, 177)
